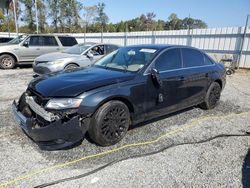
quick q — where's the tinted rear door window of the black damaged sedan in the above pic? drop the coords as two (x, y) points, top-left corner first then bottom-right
(182, 48), (204, 67)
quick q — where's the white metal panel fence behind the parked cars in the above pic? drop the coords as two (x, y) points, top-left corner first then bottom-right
(0, 27), (250, 68)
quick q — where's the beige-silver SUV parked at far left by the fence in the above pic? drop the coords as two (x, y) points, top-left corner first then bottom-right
(0, 34), (77, 69)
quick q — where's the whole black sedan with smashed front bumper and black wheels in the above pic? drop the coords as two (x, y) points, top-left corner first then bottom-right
(12, 45), (226, 150)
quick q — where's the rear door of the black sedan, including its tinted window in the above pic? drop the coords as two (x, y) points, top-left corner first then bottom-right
(181, 48), (211, 106)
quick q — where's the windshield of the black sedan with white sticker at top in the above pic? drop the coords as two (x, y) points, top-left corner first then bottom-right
(95, 47), (157, 72)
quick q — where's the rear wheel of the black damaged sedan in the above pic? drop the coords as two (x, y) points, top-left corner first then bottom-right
(199, 82), (221, 110)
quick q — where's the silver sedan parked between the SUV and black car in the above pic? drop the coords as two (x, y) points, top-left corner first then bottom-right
(33, 43), (119, 74)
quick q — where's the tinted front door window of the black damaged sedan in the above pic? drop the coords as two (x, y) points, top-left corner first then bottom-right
(155, 49), (182, 71)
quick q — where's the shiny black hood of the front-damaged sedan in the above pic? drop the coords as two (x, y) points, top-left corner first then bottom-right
(29, 66), (135, 97)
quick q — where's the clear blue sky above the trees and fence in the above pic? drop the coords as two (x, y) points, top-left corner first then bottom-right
(82, 0), (250, 28)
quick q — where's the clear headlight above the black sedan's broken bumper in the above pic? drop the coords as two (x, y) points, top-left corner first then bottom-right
(45, 98), (82, 110)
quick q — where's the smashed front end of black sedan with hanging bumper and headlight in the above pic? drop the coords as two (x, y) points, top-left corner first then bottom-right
(12, 90), (89, 150)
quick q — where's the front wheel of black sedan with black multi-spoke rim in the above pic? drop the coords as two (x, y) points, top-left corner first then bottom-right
(88, 101), (130, 146)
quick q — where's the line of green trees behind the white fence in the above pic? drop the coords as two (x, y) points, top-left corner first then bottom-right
(0, 0), (207, 33)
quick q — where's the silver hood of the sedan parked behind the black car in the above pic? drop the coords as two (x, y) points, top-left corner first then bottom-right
(35, 52), (83, 62)
